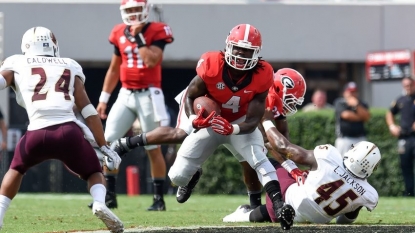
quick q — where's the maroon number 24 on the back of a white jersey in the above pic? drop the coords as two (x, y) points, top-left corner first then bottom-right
(32, 67), (71, 102)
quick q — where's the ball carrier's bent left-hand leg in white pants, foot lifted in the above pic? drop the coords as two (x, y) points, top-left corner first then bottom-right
(168, 128), (224, 203)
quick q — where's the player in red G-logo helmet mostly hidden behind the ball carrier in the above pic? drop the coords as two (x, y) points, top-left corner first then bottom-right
(114, 68), (306, 209)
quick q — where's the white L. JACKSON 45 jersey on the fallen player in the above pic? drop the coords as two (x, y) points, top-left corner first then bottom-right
(285, 145), (379, 223)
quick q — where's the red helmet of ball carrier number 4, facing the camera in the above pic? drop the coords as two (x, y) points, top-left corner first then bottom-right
(225, 24), (262, 70)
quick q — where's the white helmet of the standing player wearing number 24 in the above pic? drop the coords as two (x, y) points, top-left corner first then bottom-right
(21, 27), (59, 57)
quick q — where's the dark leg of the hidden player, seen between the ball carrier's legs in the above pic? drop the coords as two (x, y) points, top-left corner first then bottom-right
(224, 144), (262, 209)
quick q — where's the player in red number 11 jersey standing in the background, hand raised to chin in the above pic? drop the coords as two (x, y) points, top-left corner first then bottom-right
(95, 0), (173, 211)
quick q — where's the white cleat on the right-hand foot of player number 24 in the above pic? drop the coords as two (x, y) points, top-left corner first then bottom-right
(92, 201), (124, 233)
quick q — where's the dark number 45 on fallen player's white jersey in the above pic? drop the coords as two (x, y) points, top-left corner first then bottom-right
(314, 180), (358, 216)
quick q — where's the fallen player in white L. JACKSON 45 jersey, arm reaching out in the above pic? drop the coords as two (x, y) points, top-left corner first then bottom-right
(223, 110), (381, 224)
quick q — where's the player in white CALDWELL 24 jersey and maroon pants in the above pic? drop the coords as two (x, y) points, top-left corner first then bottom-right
(0, 27), (124, 233)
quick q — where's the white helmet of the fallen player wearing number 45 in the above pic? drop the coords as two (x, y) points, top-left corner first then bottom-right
(343, 141), (381, 179)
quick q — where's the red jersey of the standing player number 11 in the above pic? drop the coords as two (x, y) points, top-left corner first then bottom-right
(109, 22), (173, 89)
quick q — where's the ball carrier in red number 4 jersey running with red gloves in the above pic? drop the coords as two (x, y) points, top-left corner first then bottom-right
(168, 24), (295, 230)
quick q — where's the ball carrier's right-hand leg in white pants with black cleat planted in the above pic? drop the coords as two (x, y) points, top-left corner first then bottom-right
(229, 129), (295, 230)
